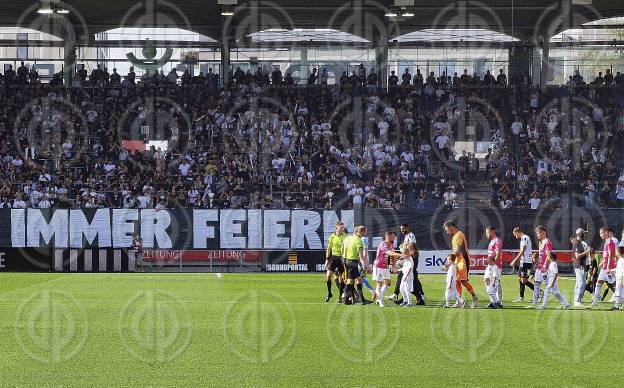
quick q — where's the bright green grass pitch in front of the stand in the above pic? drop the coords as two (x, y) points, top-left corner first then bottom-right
(0, 273), (624, 387)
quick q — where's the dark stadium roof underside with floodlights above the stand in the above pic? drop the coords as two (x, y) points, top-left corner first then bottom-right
(0, 0), (624, 42)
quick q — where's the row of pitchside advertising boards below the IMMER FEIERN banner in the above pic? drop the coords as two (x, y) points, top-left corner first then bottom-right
(0, 248), (572, 274)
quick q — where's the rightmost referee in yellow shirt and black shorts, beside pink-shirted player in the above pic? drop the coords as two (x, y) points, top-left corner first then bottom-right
(342, 226), (371, 304)
